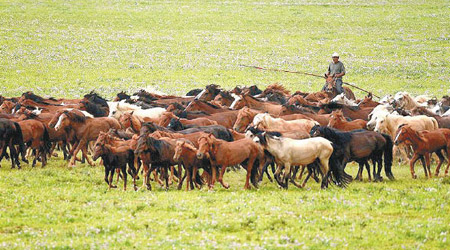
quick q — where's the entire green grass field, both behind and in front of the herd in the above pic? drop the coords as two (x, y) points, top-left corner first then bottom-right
(0, 0), (450, 249)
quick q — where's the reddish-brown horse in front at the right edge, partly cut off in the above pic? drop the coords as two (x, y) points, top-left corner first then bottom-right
(394, 124), (450, 179)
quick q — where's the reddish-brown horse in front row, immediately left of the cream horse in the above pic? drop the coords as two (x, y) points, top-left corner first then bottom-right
(197, 134), (264, 189)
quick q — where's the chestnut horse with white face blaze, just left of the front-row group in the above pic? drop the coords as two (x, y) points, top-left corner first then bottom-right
(48, 110), (120, 166)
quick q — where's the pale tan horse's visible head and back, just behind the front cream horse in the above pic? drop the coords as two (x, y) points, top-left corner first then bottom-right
(253, 113), (319, 133)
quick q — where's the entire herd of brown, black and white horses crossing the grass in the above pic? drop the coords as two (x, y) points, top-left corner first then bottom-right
(0, 81), (450, 190)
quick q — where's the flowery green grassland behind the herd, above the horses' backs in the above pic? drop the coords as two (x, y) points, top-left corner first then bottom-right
(0, 0), (450, 97)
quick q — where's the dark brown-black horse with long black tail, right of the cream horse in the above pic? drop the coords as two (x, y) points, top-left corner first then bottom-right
(310, 126), (394, 181)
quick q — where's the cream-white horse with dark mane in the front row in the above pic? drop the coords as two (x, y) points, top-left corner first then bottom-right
(253, 132), (333, 188)
